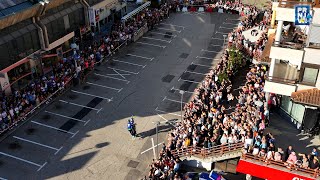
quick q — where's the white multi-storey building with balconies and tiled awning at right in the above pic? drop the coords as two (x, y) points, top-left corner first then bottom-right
(259, 0), (320, 131)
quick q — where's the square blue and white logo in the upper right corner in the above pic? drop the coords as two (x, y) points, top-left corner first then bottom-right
(294, 5), (312, 25)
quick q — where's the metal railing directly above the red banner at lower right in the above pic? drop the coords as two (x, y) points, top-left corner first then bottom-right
(241, 153), (320, 178)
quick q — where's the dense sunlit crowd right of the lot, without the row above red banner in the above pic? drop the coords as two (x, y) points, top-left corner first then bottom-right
(149, 2), (269, 179)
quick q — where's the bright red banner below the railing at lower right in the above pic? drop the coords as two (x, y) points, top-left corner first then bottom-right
(237, 159), (315, 180)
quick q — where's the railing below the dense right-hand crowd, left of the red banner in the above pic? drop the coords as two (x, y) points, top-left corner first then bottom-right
(171, 142), (244, 159)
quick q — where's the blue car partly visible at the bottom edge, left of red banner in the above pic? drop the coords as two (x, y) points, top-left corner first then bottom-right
(184, 171), (226, 180)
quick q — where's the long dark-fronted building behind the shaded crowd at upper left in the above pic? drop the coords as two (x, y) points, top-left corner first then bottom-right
(0, 0), (126, 93)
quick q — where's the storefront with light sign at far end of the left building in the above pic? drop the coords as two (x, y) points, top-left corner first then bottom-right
(88, 0), (127, 33)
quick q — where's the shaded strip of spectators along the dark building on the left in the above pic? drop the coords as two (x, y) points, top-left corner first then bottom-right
(0, 4), (169, 134)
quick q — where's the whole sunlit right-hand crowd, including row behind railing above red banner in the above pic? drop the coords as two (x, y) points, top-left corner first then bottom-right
(149, 1), (319, 179)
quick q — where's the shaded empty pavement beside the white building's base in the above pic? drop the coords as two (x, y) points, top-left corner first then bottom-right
(265, 113), (320, 154)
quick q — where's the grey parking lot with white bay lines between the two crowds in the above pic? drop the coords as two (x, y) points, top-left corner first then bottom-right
(0, 13), (237, 179)
